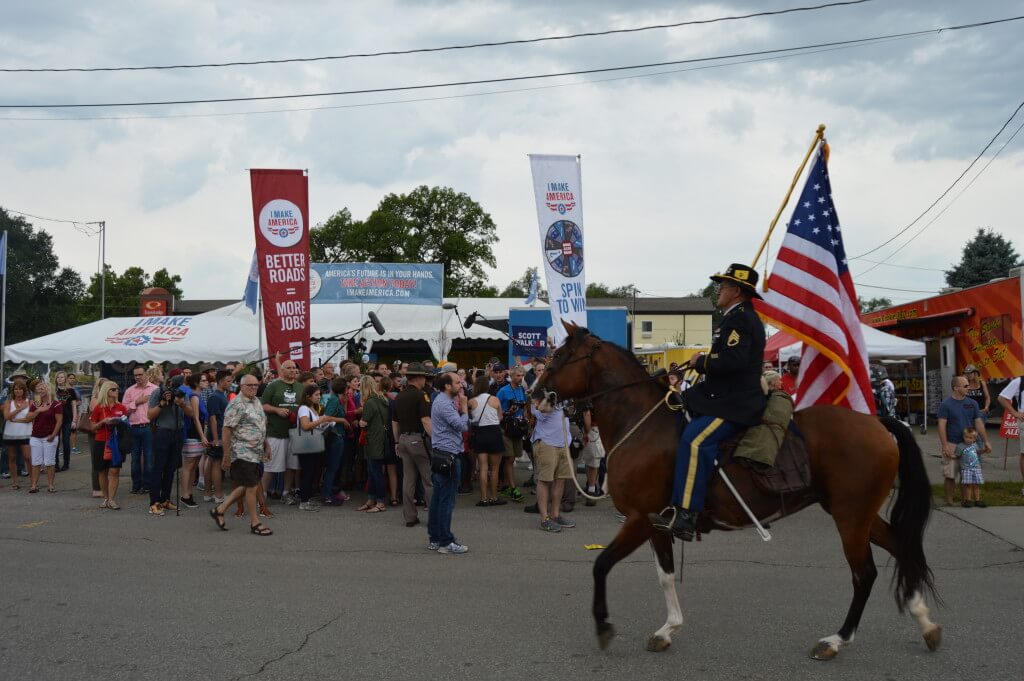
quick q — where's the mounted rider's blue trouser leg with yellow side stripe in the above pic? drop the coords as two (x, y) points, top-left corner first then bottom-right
(672, 416), (742, 512)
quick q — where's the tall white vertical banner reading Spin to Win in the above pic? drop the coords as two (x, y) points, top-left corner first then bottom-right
(529, 154), (587, 346)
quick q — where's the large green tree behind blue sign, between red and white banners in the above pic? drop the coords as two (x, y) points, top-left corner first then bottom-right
(310, 185), (498, 296)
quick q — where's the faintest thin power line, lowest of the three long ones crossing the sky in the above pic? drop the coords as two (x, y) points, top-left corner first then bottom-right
(0, 35), (923, 121)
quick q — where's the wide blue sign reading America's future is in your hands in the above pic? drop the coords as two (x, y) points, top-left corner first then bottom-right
(309, 262), (444, 305)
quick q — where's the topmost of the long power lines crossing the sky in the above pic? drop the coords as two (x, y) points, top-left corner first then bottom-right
(0, 0), (872, 74)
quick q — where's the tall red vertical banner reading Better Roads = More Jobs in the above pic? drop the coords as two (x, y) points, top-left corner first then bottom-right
(249, 169), (310, 369)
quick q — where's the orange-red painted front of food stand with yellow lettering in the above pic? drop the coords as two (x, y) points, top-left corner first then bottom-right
(860, 278), (1024, 380)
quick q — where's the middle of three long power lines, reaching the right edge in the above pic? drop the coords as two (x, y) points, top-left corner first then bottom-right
(0, 15), (1024, 109)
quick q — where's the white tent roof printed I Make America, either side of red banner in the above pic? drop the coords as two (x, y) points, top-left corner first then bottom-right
(4, 298), (522, 363)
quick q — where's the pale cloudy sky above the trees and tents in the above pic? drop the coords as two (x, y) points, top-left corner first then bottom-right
(0, 0), (1024, 301)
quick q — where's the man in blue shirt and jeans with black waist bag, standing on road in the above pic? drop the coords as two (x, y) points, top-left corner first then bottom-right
(427, 373), (469, 554)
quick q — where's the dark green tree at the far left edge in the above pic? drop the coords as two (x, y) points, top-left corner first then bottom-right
(0, 208), (85, 343)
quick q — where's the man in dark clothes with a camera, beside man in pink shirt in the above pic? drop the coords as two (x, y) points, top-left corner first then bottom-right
(146, 372), (193, 515)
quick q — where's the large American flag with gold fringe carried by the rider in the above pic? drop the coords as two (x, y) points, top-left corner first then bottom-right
(755, 141), (874, 414)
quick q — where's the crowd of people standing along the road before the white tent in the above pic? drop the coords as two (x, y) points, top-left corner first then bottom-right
(3, 358), (604, 554)
